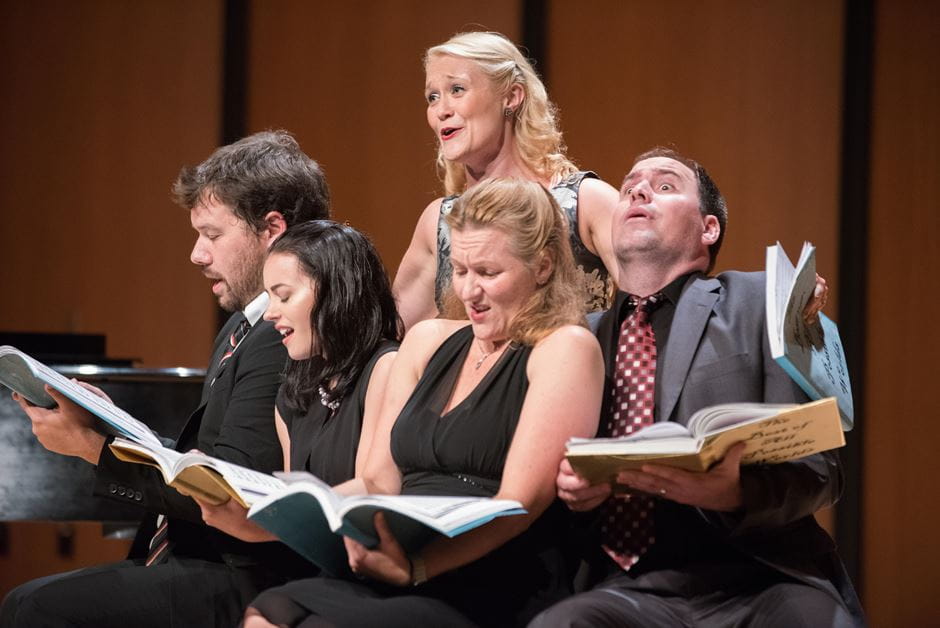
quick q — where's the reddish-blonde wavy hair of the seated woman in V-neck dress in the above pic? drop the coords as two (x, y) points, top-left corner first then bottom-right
(444, 178), (585, 345)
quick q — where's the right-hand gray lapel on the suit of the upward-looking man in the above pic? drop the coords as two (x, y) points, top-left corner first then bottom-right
(659, 277), (721, 421)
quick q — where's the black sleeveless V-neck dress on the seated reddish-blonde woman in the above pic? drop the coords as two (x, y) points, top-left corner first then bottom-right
(253, 325), (570, 627)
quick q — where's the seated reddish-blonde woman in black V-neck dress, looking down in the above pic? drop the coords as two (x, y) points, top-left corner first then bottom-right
(245, 179), (604, 628)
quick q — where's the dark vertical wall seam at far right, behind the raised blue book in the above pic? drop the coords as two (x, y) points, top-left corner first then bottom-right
(836, 0), (874, 596)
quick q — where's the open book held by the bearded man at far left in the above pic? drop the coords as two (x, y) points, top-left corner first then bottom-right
(0, 345), (160, 447)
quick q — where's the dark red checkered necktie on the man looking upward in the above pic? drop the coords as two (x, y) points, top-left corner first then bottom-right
(600, 293), (663, 571)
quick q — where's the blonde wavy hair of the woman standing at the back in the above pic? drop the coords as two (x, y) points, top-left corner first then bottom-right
(424, 32), (577, 195)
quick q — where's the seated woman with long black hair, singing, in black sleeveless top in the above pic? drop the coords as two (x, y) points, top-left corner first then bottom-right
(200, 220), (402, 541)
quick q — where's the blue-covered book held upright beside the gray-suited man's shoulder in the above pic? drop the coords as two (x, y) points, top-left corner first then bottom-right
(767, 242), (855, 430)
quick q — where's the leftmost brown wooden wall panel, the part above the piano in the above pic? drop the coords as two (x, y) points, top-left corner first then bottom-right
(0, 0), (221, 366)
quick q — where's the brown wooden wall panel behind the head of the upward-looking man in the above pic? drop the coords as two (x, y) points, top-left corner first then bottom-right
(548, 0), (842, 284)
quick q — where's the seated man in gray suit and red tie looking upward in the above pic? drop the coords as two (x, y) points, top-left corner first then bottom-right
(533, 149), (863, 627)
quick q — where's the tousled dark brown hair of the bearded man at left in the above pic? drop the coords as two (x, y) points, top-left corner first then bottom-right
(173, 131), (330, 233)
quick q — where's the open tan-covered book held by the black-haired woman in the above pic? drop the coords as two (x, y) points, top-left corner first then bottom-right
(109, 437), (286, 508)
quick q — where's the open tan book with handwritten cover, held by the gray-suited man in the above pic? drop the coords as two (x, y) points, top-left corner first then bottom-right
(565, 397), (845, 482)
